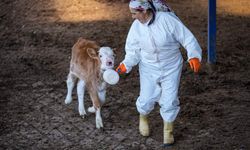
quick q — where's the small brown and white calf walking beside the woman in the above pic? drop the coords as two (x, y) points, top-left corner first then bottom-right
(65, 38), (114, 128)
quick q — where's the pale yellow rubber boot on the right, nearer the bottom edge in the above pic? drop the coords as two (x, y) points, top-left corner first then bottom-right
(163, 121), (174, 147)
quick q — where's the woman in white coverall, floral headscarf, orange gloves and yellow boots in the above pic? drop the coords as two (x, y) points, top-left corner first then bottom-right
(116, 0), (202, 146)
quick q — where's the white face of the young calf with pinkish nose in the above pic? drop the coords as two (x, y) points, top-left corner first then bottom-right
(99, 47), (114, 70)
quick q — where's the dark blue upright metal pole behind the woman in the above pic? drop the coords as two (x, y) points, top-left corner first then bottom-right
(208, 0), (216, 64)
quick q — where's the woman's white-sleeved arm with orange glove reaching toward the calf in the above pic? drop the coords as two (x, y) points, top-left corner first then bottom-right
(116, 22), (140, 74)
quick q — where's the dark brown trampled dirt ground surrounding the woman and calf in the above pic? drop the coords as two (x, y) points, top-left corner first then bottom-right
(0, 0), (250, 150)
